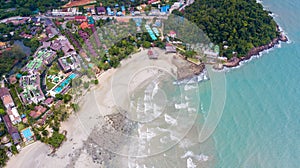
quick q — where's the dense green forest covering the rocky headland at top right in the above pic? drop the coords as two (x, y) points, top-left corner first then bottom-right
(182, 0), (279, 58)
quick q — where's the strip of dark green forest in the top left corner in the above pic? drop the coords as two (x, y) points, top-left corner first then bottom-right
(0, 0), (67, 19)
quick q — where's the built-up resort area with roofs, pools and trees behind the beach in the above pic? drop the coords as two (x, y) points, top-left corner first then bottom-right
(0, 0), (223, 166)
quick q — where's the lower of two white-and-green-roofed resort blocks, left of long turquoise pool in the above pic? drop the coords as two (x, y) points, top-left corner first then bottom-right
(20, 73), (45, 104)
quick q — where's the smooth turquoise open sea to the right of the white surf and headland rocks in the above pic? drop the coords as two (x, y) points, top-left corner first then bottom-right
(210, 0), (300, 168)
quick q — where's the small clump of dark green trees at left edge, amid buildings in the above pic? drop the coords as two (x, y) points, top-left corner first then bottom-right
(0, 47), (26, 76)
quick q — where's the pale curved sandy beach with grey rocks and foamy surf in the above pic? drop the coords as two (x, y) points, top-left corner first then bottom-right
(7, 49), (213, 168)
